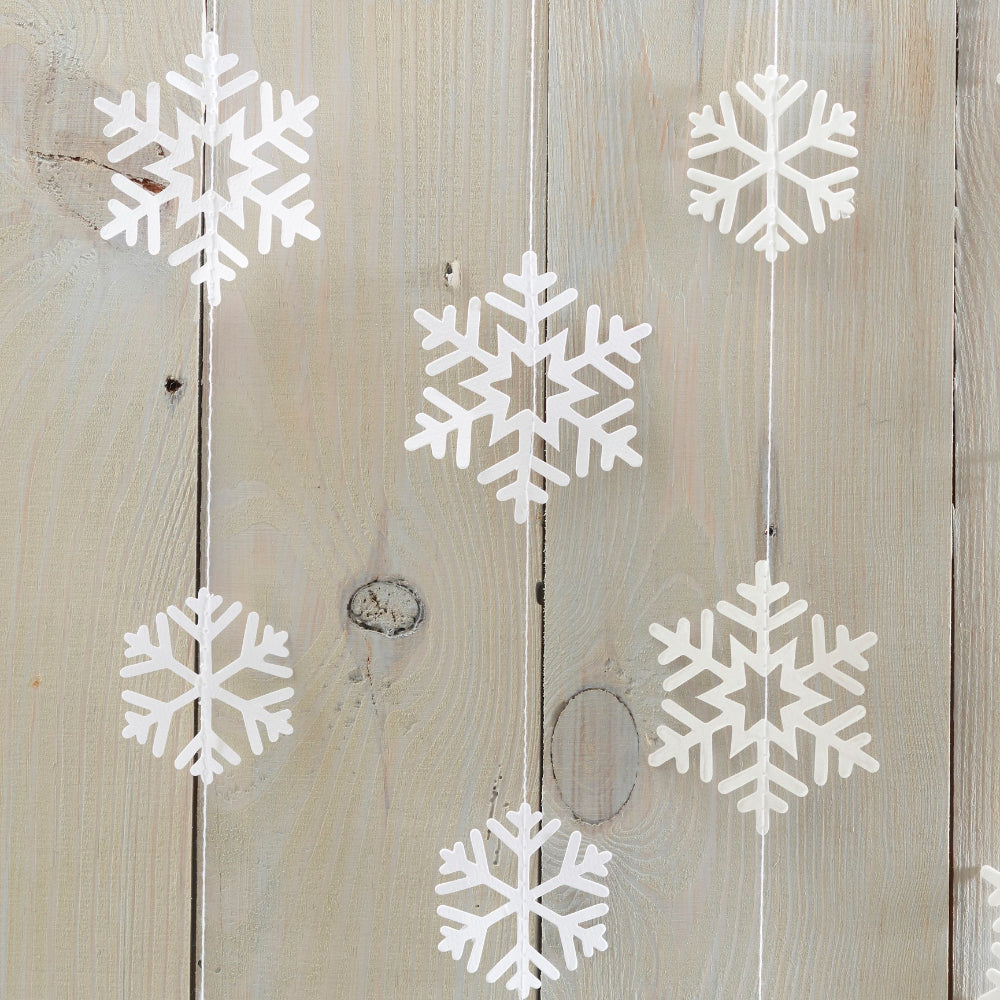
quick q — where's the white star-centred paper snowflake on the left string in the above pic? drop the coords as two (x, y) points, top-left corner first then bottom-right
(94, 31), (320, 305)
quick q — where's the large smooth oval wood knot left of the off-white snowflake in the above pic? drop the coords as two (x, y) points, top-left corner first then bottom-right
(552, 688), (639, 823)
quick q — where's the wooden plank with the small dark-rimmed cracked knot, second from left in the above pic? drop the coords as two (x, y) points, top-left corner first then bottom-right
(206, 0), (544, 1000)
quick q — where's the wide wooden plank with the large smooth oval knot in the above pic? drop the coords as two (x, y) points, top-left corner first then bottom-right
(543, 0), (954, 1000)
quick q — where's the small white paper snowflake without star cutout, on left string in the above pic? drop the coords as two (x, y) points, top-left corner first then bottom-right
(121, 587), (294, 784)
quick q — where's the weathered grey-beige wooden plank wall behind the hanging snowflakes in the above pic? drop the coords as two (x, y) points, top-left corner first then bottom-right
(0, 0), (984, 1000)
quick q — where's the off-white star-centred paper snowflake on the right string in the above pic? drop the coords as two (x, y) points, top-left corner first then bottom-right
(649, 561), (879, 835)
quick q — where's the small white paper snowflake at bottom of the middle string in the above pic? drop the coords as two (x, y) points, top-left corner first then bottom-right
(435, 802), (611, 1000)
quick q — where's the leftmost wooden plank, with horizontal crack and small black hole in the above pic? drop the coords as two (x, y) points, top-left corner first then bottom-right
(0, 0), (199, 1000)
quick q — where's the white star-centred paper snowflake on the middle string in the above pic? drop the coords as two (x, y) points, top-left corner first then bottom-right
(405, 250), (652, 524)
